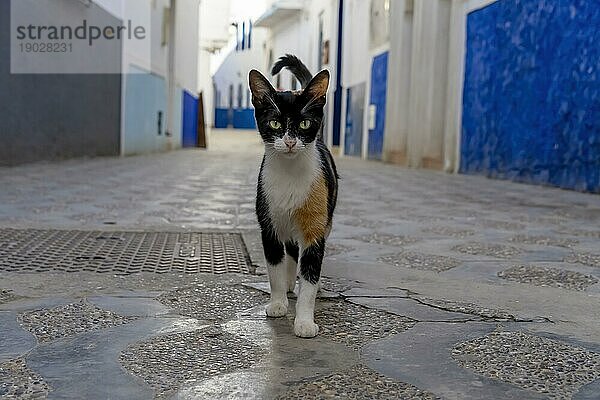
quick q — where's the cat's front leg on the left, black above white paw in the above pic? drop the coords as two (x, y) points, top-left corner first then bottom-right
(262, 230), (288, 318)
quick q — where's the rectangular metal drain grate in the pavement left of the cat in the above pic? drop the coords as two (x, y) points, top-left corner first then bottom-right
(0, 229), (251, 275)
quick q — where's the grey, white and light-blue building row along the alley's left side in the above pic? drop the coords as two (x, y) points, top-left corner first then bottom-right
(0, 0), (209, 165)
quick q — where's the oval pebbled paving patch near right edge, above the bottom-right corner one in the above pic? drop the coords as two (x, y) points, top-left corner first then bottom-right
(498, 265), (598, 290)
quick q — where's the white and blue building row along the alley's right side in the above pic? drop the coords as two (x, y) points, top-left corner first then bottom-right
(245, 0), (600, 192)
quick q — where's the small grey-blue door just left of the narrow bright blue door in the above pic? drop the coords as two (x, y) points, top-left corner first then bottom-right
(344, 83), (366, 157)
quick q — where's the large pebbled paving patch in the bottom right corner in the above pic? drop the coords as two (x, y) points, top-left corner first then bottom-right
(452, 332), (600, 399)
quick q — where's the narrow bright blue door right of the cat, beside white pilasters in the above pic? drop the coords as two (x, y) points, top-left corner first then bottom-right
(368, 51), (388, 160)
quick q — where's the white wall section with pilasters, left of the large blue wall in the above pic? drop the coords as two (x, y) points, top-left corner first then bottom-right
(384, 0), (494, 172)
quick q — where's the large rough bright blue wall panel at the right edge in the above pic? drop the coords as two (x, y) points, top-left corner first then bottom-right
(461, 0), (600, 192)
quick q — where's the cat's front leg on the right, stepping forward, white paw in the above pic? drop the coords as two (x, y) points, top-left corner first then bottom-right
(294, 239), (325, 338)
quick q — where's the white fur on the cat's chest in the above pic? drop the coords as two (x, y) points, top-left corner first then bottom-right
(261, 142), (320, 242)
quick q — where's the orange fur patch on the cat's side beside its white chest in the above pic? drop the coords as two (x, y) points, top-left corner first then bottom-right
(294, 175), (329, 246)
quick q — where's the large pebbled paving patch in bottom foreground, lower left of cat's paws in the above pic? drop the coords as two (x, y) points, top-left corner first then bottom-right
(119, 326), (265, 397)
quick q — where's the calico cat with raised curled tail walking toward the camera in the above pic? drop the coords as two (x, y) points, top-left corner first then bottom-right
(248, 54), (338, 338)
